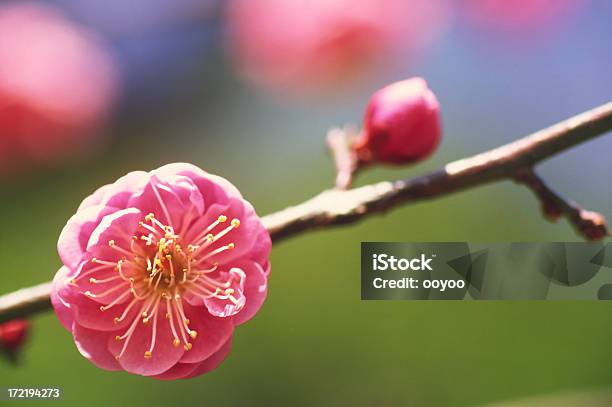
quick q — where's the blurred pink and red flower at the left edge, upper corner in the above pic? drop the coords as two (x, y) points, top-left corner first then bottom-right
(0, 2), (117, 175)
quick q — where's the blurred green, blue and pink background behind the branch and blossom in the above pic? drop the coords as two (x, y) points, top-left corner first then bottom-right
(0, 0), (612, 407)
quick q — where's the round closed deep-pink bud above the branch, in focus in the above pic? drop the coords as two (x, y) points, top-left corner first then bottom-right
(354, 78), (441, 164)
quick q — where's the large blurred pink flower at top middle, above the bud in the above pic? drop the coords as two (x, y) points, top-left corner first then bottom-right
(227, 0), (448, 93)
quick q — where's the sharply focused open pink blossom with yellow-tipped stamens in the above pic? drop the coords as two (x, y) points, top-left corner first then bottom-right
(51, 164), (271, 379)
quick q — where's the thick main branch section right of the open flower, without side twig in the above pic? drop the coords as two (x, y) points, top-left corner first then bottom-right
(263, 102), (612, 240)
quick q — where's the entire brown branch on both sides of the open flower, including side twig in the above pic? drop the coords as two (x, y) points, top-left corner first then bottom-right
(0, 102), (612, 322)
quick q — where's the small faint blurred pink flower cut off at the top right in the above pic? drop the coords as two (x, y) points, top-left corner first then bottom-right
(458, 0), (584, 37)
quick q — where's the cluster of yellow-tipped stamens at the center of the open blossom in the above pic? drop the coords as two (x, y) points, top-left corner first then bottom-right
(70, 209), (240, 359)
